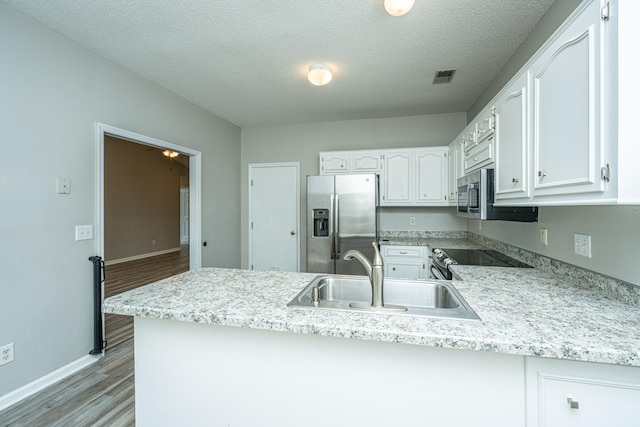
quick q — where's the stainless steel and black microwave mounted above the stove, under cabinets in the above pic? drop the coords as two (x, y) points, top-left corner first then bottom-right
(458, 169), (538, 222)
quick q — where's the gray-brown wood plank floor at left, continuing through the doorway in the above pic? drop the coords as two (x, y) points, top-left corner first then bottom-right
(0, 246), (189, 427)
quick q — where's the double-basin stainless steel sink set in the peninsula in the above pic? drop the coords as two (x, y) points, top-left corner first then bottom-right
(287, 275), (480, 320)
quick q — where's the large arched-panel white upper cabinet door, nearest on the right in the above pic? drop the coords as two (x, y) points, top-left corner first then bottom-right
(532, 0), (604, 196)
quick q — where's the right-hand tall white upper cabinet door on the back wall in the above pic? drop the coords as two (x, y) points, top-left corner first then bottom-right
(415, 147), (448, 206)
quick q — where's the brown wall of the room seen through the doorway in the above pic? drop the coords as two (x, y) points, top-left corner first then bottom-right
(104, 136), (189, 264)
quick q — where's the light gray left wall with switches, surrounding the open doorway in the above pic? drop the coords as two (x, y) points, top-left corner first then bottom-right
(0, 2), (240, 396)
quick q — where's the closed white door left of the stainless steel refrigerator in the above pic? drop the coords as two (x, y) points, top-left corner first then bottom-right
(249, 163), (300, 271)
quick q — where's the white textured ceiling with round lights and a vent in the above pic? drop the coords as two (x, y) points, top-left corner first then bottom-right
(4, 0), (553, 127)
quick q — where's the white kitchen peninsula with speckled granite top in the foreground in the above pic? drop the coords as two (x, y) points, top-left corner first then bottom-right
(104, 267), (640, 426)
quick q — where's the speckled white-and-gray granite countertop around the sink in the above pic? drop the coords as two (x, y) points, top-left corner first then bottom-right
(104, 266), (640, 366)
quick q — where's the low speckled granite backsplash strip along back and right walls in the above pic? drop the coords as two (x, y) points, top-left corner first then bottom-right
(379, 230), (640, 307)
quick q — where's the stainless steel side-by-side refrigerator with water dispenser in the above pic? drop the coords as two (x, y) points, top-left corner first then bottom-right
(307, 174), (378, 275)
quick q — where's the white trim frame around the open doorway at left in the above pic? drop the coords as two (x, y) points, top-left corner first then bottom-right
(95, 122), (202, 270)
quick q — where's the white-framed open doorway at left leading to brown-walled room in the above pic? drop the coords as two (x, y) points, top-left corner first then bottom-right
(96, 123), (201, 347)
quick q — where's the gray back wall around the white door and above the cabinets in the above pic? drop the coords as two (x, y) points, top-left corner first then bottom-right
(241, 113), (466, 271)
